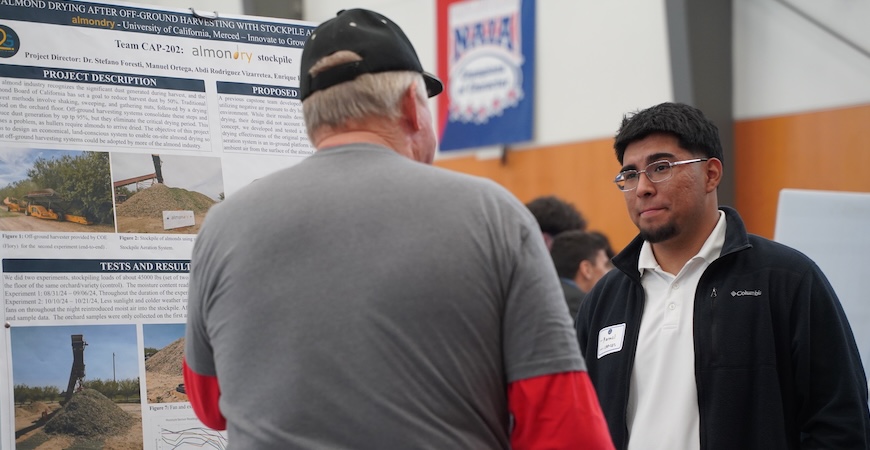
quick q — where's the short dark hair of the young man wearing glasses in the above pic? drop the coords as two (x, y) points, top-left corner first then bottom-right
(613, 102), (724, 164)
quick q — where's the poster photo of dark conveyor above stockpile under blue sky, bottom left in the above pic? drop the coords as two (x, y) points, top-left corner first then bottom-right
(10, 325), (142, 449)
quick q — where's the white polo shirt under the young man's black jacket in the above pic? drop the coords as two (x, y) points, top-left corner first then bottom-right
(626, 211), (726, 450)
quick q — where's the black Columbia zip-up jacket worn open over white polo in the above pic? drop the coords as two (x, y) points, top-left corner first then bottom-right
(576, 207), (870, 450)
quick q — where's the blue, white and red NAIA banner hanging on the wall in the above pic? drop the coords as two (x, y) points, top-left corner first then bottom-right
(438, 0), (535, 150)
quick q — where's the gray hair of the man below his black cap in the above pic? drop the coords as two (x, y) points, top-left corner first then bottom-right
(302, 51), (427, 138)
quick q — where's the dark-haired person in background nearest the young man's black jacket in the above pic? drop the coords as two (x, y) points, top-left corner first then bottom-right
(550, 230), (613, 318)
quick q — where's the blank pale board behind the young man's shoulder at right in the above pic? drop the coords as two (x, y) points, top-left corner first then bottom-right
(774, 189), (870, 392)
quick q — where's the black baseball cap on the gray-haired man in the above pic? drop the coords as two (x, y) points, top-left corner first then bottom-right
(299, 9), (444, 100)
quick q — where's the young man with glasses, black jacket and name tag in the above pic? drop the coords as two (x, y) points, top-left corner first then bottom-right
(576, 103), (870, 449)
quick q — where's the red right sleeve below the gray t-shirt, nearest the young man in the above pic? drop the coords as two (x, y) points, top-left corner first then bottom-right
(508, 372), (614, 450)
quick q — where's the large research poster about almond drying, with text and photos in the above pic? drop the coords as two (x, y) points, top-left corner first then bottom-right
(0, 0), (313, 449)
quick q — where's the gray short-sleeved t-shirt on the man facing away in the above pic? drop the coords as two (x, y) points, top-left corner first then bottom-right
(185, 145), (585, 450)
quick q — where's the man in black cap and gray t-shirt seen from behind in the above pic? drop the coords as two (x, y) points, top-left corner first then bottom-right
(184, 9), (612, 450)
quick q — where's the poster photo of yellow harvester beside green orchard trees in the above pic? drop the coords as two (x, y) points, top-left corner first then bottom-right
(0, 148), (115, 233)
